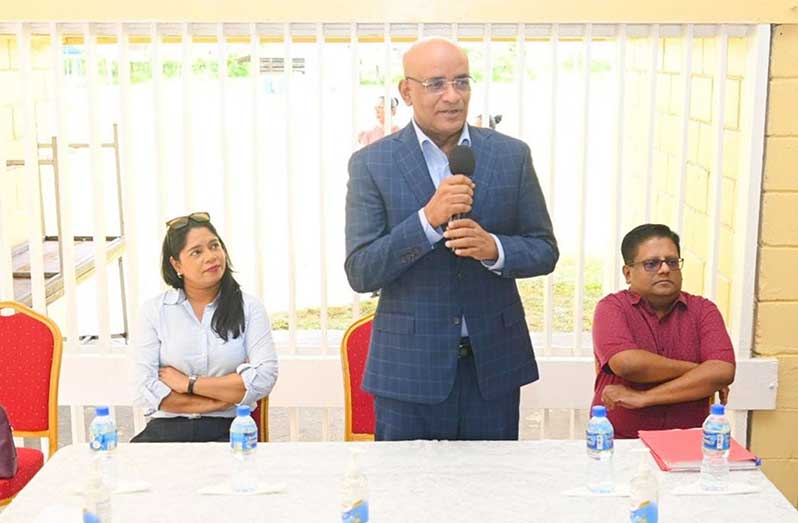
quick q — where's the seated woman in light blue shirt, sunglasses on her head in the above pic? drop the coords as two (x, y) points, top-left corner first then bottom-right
(131, 212), (277, 442)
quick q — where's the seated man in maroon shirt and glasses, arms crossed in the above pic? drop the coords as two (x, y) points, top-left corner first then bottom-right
(593, 224), (735, 438)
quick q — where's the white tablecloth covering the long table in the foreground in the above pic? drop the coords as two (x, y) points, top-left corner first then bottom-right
(0, 441), (798, 523)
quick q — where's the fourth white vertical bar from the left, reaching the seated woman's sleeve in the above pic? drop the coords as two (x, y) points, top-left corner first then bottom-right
(114, 23), (139, 342)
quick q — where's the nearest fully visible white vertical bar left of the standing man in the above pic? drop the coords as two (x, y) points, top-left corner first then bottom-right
(316, 23), (330, 355)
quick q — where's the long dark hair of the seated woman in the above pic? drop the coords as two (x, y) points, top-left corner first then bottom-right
(161, 219), (244, 342)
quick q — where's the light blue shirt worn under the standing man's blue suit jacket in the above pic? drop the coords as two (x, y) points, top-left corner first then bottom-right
(412, 118), (504, 337)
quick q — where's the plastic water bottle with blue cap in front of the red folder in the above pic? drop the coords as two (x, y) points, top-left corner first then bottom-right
(701, 403), (731, 491)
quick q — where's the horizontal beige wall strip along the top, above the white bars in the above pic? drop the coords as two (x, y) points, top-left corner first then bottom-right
(0, 0), (798, 23)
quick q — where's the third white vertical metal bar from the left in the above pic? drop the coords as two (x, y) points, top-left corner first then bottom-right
(83, 23), (111, 352)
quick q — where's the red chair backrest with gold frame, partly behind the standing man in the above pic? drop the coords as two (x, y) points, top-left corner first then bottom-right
(341, 313), (375, 441)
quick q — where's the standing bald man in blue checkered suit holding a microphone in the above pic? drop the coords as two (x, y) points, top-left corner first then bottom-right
(345, 38), (559, 440)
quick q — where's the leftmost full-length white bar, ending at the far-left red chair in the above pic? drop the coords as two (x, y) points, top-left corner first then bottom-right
(17, 23), (47, 314)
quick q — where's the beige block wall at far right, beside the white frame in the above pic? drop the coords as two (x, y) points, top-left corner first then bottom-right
(751, 24), (798, 506)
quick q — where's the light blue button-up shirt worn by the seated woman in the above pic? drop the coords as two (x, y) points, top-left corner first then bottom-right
(132, 289), (277, 418)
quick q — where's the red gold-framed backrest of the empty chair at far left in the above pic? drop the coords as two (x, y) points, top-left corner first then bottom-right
(0, 302), (62, 456)
